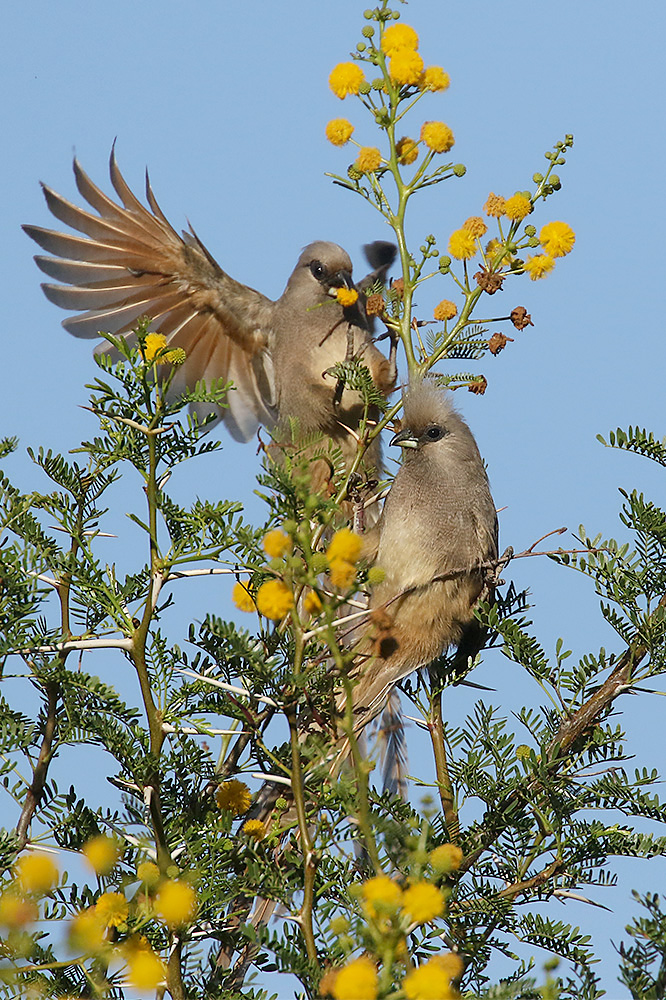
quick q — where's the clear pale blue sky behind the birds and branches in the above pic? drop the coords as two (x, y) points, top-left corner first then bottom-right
(0, 0), (666, 997)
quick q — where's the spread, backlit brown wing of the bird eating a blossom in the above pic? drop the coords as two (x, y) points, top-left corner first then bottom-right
(23, 152), (275, 441)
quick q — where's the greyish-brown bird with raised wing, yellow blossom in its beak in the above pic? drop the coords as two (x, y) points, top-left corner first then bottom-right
(23, 151), (395, 478)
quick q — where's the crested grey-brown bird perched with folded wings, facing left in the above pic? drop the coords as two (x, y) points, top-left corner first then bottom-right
(337, 381), (498, 744)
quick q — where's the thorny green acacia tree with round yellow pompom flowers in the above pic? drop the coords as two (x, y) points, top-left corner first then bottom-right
(0, 0), (666, 1000)
